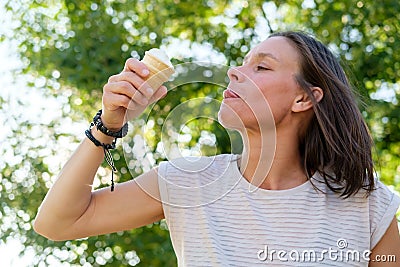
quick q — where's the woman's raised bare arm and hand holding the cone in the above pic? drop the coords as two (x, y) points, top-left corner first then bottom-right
(34, 59), (166, 240)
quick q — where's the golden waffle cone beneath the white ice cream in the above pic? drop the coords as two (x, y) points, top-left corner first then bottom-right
(142, 53), (175, 90)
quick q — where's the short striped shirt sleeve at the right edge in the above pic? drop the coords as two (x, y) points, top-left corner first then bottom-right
(369, 181), (400, 250)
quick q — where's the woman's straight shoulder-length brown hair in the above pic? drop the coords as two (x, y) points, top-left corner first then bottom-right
(270, 32), (374, 198)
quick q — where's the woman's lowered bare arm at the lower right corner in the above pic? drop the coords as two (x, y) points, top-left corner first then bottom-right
(369, 217), (400, 267)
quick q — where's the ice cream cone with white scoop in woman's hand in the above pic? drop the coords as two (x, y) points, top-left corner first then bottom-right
(142, 48), (175, 90)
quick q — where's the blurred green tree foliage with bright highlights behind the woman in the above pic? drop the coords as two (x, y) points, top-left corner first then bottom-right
(0, 0), (400, 266)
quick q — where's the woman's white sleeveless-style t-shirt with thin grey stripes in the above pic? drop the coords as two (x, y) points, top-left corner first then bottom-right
(158, 154), (400, 267)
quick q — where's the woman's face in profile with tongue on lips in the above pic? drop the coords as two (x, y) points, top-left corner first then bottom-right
(218, 37), (301, 131)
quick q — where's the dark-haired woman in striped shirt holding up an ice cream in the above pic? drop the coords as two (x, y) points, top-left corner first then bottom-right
(34, 32), (400, 266)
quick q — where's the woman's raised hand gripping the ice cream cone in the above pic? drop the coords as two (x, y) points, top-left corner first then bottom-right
(101, 58), (167, 131)
